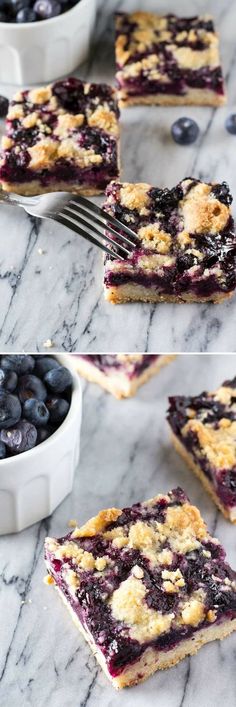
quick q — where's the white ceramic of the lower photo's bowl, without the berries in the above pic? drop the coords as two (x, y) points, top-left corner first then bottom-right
(0, 356), (82, 535)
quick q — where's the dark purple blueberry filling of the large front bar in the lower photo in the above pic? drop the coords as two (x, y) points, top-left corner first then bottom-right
(46, 489), (236, 677)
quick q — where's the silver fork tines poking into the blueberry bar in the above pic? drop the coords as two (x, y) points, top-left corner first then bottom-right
(56, 196), (137, 260)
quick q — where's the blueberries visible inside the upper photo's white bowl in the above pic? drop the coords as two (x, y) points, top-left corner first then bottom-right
(0, 0), (79, 24)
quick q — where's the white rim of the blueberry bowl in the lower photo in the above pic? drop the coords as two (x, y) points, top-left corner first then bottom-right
(0, 353), (82, 470)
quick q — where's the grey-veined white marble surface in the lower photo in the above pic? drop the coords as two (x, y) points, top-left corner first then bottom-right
(0, 355), (236, 707)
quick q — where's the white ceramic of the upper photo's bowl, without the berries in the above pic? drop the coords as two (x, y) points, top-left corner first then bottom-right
(0, 0), (96, 85)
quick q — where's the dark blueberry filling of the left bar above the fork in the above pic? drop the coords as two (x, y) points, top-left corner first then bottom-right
(0, 78), (118, 189)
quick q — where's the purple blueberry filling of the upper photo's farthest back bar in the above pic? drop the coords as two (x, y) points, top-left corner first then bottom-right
(117, 13), (224, 96)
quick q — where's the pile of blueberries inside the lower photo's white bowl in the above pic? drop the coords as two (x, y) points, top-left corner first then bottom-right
(0, 354), (72, 459)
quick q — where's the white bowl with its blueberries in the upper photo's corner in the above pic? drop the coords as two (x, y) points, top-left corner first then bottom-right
(0, 0), (96, 85)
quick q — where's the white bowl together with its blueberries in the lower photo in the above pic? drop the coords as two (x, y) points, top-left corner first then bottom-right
(0, 354), (82, 535)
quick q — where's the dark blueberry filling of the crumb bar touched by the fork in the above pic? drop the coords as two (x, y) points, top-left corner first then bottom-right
(105, 179), (236, 298)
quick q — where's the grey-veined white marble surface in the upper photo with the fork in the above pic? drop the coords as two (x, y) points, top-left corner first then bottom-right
(0, 0), (236, 352)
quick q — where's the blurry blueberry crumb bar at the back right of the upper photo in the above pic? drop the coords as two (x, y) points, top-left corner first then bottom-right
(116, 12), (226, 107)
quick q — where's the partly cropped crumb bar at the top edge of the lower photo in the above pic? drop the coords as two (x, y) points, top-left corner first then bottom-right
(73, 354), (175, 398)
